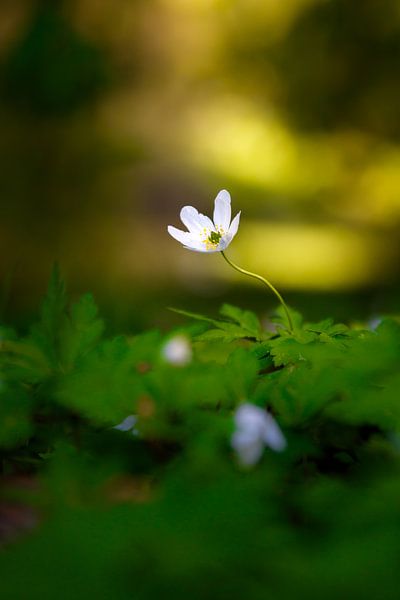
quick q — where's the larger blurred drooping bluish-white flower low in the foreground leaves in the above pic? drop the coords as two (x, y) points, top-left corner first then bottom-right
(231, 403), (286, 467)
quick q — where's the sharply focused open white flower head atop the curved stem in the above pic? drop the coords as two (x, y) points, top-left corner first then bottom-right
(168, 190), (240, 252)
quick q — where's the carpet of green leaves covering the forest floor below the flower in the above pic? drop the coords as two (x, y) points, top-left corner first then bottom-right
(0, 269), (400, 600)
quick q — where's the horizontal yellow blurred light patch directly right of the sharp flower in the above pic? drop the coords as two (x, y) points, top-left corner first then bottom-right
(227, 222), (391, 291)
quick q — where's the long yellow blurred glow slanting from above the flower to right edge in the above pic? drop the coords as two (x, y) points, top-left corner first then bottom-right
(186, 95), (400, 227)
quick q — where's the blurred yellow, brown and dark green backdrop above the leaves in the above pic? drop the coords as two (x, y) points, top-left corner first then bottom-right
(0, 0), (400, 328)
